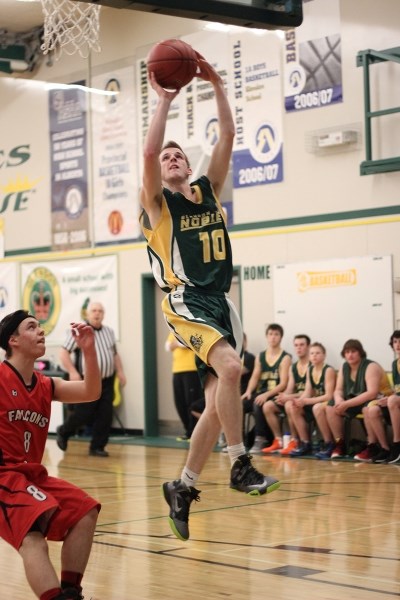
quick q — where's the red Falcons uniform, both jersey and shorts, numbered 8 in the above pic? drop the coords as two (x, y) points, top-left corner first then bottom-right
(0, 361), (100, 550)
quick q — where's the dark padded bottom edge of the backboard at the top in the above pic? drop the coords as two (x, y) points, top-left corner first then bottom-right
(73, 0), (303, 29)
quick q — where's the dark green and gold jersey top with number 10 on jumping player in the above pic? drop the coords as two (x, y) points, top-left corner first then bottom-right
(140, 175), (233, 293)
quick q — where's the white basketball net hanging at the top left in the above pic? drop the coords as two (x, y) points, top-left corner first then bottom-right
(41, 0), (101, 60)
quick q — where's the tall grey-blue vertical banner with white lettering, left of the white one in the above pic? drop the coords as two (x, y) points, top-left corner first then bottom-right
(49, 84), (90, 250)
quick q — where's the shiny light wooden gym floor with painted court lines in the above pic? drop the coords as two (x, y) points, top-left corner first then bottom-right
(0, 439), (400, 600)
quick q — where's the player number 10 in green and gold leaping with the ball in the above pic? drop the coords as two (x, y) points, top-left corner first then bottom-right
(140, 55), (280, 540)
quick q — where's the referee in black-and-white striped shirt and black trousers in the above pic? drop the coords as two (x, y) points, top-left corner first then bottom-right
(56, 302), (126, 457)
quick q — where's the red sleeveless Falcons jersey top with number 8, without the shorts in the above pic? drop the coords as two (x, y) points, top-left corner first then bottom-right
(0, 361), (54, 466)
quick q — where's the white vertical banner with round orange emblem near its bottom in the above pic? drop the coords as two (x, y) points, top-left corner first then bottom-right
(91, 66), (140, 245)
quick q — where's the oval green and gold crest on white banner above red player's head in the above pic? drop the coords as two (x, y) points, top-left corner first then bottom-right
(22, 267), (61, 335)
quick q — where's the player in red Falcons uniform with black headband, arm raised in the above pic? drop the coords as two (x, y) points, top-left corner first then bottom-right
(0, 310), (101, 600)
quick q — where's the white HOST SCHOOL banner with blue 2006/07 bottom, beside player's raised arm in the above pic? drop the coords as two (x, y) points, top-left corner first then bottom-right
(231, 31), (283, 188)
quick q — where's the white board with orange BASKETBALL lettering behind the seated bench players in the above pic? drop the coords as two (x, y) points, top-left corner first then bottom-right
(273, 256), (394, 370)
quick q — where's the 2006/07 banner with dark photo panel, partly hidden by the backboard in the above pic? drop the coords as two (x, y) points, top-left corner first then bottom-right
(284, 0), (343, 112)
